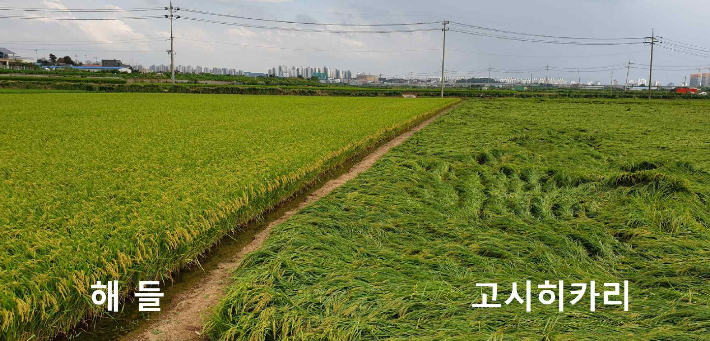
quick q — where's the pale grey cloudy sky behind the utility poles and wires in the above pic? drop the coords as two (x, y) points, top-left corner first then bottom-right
(0, 0), (710, 85)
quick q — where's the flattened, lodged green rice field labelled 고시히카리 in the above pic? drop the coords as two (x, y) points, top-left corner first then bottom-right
(206, 99), (710, 340)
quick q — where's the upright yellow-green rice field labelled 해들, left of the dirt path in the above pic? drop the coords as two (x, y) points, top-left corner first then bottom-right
(0, 93), (457, 340)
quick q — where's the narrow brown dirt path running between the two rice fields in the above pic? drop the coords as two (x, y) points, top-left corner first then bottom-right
(122, 104), (458, 341)
